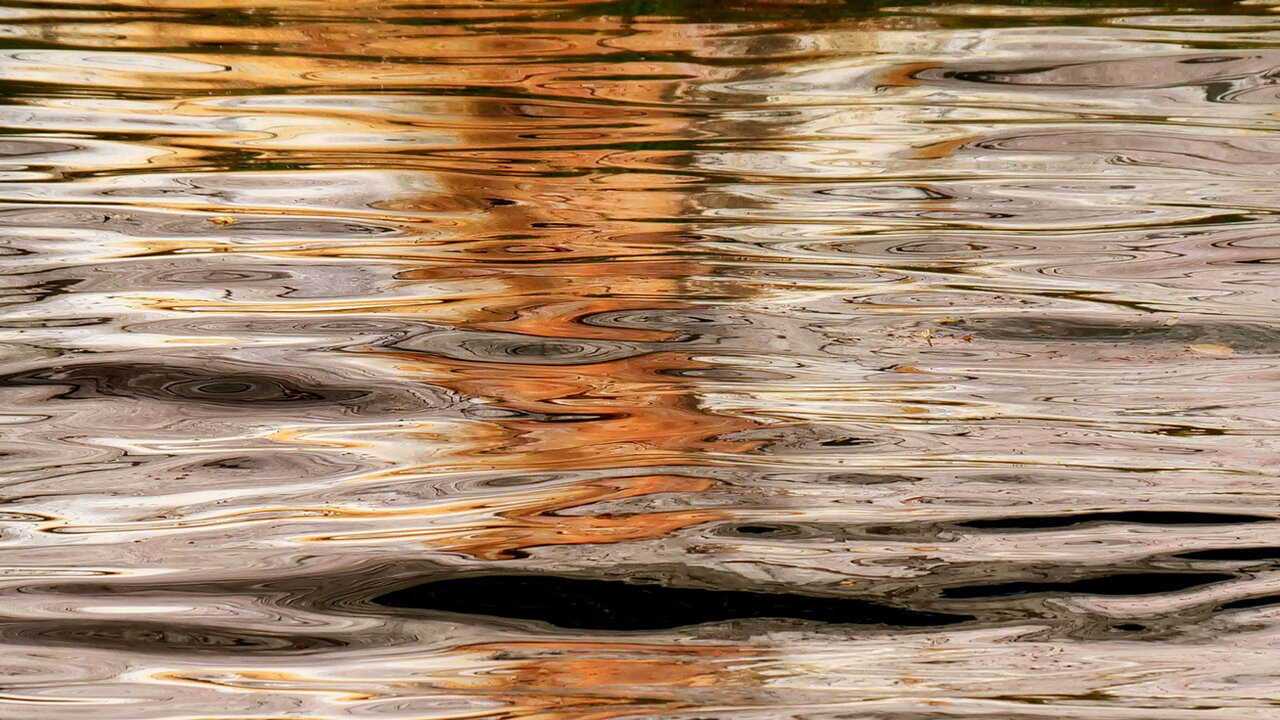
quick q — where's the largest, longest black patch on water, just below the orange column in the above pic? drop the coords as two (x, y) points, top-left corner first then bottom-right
(375, 575), (973, 630)
